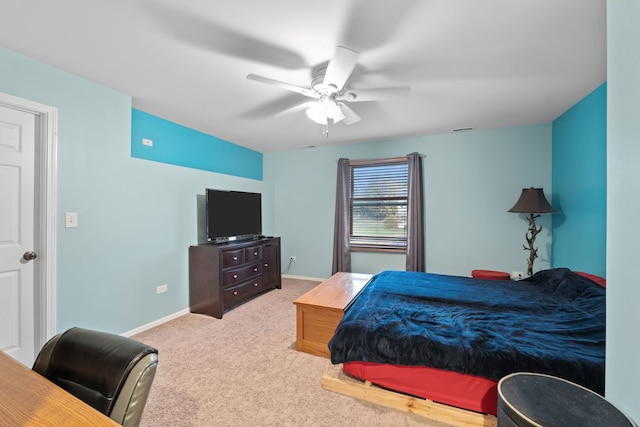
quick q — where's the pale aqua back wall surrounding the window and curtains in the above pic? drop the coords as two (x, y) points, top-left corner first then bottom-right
(264, 124), (551, 278)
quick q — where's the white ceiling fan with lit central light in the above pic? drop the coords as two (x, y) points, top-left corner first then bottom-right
(247, 46), (411, 135)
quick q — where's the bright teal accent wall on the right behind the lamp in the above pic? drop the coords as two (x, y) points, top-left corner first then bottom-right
(551, 83), (607, 277)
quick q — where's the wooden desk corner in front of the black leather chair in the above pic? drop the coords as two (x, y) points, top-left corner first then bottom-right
(0, 351), (119, 427)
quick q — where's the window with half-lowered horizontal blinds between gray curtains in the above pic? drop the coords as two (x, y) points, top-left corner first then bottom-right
(349, 157), (408, 252)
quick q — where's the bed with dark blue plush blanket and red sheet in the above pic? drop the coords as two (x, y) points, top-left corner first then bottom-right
(329, 269), (605, 415)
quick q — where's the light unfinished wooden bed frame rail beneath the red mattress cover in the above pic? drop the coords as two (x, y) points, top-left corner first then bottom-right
(321, 362), (497, 427)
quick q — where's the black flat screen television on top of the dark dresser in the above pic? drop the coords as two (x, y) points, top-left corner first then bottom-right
(205, 188), (262, 243)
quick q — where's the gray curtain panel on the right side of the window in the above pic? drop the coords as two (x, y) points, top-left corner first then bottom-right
(407, 153), (425, 271)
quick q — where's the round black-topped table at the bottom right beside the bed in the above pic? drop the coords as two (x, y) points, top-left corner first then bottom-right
(498, 372), (635, 427)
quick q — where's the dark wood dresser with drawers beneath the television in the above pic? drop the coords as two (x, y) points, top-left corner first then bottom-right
(189, 237), (282, 319)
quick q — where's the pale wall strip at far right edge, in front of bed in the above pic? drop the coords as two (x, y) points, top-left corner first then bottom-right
(606, 0), (640, 423)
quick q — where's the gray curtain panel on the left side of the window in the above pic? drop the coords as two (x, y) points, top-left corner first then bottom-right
(331, 159), (351, 274)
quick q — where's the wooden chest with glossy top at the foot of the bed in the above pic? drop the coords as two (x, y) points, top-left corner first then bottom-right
(293, 273), (371, 358)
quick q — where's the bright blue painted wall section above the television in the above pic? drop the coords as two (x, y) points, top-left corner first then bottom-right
(131, 108), (262, 180)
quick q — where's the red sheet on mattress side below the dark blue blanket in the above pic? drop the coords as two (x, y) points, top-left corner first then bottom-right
(342, 362), (498, 415)
